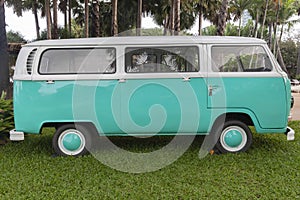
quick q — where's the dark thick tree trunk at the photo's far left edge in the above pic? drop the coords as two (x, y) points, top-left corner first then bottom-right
(0, 0), (9, 96)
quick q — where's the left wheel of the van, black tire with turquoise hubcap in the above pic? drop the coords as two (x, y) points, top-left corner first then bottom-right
(52, 124), (94, 156)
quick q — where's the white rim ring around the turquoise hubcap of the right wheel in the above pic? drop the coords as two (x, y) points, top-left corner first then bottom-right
(220, 126), (247, 152)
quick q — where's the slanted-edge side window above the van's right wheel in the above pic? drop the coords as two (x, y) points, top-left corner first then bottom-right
(212, 46), (273, 72)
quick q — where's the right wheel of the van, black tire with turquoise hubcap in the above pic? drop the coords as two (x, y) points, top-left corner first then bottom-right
(212, 120), (252, 153)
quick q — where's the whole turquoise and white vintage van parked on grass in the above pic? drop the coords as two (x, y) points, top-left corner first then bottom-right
(10, 36), (294, 156)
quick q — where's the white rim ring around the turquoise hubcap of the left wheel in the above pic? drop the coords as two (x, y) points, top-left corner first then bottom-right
(58, 129), (86, 155)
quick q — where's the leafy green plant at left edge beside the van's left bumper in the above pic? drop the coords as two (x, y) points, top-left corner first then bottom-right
(0, 92), (14, 136)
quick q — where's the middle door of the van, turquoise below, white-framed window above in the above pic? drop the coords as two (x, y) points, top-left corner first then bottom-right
(121, 46), (207, 134)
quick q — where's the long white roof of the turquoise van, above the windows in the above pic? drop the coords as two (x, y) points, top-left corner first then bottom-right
(25, 36), (266, 47)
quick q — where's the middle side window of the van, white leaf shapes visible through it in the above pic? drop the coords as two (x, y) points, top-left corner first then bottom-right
(125, 47), (199, 73)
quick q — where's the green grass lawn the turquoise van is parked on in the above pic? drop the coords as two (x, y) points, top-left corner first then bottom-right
(0, 122), (300, 199)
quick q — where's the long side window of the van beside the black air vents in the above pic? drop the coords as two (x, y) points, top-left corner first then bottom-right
(39, 48), (116, 74)
